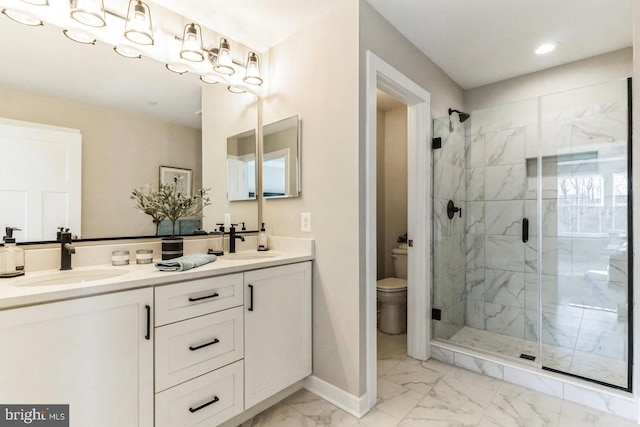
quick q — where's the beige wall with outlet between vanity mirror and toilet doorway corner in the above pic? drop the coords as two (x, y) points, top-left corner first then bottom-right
(262, 2), (364, 396)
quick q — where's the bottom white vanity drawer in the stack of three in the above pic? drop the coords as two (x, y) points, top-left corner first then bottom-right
(155, 360), (244, 427)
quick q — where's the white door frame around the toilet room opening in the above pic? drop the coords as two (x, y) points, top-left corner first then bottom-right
(363, 51), (431, 413)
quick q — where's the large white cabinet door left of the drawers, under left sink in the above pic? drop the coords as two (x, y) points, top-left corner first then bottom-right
(0, 289), (153, 427)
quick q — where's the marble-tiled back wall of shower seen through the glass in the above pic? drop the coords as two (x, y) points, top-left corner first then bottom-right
(464, 82), (627, 353)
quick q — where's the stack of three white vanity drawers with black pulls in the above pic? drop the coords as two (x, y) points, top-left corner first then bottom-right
(155, 273), (244, 427)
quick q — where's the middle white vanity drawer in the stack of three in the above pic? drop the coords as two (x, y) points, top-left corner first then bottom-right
(155, 307), (244, 392)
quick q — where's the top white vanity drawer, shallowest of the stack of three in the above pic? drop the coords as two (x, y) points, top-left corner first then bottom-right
(155, 273), (242, 326)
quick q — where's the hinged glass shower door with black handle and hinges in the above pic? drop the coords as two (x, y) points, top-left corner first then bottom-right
(433, 100), (539, 363)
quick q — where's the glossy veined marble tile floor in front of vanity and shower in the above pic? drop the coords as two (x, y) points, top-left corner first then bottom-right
(242, 338), (636, 427)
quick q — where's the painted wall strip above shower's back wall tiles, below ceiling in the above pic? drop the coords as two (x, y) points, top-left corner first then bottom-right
(464, 48), (633, 112)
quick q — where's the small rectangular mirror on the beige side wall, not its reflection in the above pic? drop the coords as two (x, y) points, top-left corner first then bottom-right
(262, 116), (300, 198)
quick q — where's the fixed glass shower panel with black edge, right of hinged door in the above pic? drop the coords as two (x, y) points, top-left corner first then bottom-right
(540, 80), (630, 389)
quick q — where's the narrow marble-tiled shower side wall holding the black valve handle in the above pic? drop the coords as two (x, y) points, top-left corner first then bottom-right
(432, 116), (466, 339)
